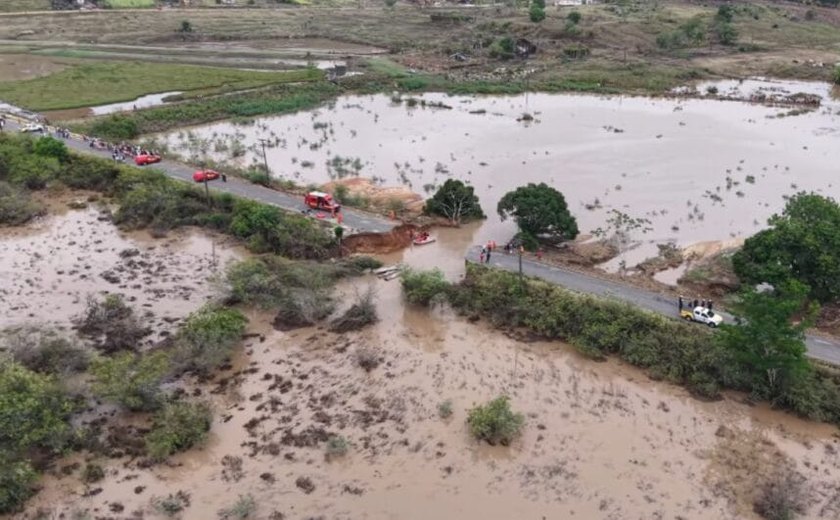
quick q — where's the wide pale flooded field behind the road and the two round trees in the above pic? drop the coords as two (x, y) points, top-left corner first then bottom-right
(163, 82), (840, 265)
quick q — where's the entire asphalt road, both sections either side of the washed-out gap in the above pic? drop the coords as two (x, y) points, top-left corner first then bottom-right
(6, 120), (840, 365)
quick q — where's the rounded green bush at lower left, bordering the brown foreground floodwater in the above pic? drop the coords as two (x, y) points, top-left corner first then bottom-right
(146, 401), (213, 461)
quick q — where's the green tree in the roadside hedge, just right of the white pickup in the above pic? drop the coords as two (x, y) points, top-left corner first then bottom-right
(715, 280), (817, 398)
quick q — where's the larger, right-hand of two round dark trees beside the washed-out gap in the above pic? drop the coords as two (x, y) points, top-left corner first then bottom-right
(497, 183), (579, 244)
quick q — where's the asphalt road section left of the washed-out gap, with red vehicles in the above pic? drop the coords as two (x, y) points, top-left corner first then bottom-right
(1, 119), (395, 235)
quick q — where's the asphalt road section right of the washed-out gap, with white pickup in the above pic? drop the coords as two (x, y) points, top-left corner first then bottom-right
(466, 247), (840, 365)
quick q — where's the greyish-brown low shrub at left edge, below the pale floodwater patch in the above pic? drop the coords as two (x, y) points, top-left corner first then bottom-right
(0, 328), (88, 375)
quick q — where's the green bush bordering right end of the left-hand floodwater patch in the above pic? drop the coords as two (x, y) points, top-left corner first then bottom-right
(175, 306), (248, 373)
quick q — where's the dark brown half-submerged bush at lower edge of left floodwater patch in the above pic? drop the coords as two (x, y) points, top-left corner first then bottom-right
(75, 294), (150, 353)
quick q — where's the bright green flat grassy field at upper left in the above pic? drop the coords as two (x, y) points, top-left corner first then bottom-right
(0, 62), (323, 110)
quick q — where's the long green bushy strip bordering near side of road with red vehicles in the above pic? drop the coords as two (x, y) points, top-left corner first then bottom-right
(0, 134), (335, 258)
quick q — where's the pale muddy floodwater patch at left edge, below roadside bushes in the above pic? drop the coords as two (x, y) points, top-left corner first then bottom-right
(0, 208), (244, 340)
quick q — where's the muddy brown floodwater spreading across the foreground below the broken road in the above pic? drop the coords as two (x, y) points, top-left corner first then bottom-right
(22, 279), (840, 520)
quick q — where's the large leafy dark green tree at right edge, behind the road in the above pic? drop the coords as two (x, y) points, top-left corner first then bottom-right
(732, 193), (840, 303)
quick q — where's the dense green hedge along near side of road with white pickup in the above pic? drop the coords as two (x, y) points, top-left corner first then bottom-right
(403, 265), (840, 424)
